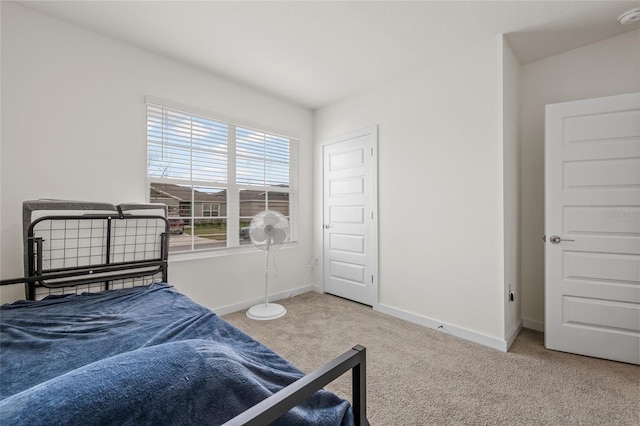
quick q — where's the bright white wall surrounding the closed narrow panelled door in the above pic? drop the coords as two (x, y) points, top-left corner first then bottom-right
(315, 37), (505, 342)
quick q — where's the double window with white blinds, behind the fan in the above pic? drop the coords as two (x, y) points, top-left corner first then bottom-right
(147, 103), (298, 252)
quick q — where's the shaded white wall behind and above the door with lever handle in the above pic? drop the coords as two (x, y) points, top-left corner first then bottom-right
(521, 30), (640, 330)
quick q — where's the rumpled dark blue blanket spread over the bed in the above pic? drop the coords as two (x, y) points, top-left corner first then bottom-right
(0, 284), (353, 425)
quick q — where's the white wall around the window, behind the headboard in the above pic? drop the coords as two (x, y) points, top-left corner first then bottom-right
(0, 2), (313, 309)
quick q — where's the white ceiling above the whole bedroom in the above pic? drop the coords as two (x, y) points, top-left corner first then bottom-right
(20, 0), (640, 109)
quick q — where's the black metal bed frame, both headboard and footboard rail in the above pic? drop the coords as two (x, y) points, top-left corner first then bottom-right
(0, 202), (368, 426)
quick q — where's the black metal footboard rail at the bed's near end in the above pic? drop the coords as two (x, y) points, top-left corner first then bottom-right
(223, 345), (367, 426)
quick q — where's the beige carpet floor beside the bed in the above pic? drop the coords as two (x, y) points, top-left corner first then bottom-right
(224, 292), (640, 426)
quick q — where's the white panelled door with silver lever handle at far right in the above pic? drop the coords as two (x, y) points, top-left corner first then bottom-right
(545, 93), (640, 364)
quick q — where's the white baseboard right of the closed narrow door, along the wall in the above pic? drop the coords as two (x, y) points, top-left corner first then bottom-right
(375, 304), (510, 352)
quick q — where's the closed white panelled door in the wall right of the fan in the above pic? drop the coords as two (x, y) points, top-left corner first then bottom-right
(322, 127), (378, 306)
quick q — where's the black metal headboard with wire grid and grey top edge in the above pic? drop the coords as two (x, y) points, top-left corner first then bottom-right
(0, 200), (169, 300)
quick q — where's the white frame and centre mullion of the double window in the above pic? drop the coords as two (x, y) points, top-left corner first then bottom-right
(145, 96), (300, 258)
